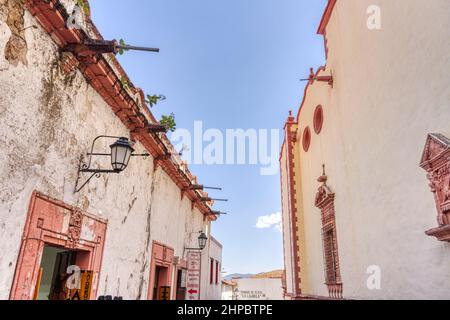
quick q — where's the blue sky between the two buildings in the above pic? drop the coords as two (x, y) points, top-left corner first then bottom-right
(90, 0), (326, 273)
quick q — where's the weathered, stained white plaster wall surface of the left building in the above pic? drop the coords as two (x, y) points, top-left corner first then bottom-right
(0, 0), (211, 299)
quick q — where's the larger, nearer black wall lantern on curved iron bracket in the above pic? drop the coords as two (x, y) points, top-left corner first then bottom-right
(75, 136), (150, 192)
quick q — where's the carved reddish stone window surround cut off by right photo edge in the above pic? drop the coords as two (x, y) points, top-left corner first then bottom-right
(420, 133), (450, 242)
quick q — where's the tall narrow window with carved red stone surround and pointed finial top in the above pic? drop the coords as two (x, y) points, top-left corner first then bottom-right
(314, 165), (343, 299)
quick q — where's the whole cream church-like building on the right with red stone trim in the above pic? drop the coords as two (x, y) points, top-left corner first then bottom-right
(280, 0), (450, 299)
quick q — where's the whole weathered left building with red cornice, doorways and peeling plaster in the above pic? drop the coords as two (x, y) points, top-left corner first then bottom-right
(0, 0), (221, 300)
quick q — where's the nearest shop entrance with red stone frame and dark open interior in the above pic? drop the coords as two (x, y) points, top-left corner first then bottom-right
(10, 192), (107, 300)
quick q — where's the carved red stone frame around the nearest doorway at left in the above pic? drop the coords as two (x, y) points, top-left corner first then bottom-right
(9, 191), (107, 300)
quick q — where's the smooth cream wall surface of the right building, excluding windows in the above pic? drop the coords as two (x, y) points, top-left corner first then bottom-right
(299, 0), (450, 299)
